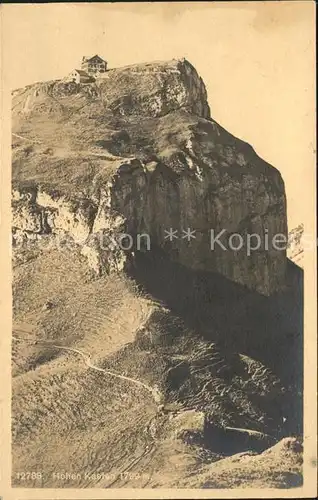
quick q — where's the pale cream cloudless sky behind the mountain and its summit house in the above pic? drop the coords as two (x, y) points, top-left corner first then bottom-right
(1, 0), (315, 229)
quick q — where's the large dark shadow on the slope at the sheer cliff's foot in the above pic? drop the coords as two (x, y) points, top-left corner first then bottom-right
(130, 249), (303, 435)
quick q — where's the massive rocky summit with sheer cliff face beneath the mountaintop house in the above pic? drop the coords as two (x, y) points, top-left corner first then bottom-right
(13, 60), (287, 295)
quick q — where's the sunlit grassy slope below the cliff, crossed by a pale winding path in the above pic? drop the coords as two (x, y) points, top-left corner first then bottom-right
(12, 245), (300, 487)
